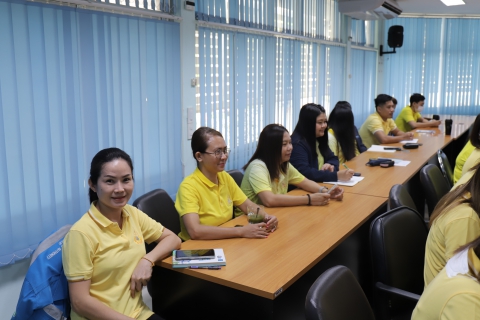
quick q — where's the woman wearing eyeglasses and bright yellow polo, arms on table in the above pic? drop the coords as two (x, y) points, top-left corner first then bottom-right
(175, 127), (278, 240)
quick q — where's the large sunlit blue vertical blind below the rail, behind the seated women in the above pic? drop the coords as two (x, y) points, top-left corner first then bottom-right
(196, 27), (345, 169)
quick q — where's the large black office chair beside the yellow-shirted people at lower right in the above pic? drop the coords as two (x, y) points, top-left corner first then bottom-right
(370, 207), (428, 319)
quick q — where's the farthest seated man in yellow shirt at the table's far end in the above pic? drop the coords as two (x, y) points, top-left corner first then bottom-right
(395, 93), (441, 132)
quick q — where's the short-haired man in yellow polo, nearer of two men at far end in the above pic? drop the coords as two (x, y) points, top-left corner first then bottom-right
(359, 94), (413, 148)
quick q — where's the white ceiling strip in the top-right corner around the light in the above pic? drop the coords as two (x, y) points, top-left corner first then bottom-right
(396, 0), (480, 16)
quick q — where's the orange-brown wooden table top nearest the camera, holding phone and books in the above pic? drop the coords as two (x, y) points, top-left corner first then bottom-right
(161, 191), (385, 299)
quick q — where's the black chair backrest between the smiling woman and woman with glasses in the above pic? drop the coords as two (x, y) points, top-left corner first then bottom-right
(133, 189), (180, 240)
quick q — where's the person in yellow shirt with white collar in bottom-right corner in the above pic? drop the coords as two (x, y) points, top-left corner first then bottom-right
(412, 238), (480, 320)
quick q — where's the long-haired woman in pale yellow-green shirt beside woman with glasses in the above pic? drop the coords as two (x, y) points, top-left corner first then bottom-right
(241, 124), (343, 207)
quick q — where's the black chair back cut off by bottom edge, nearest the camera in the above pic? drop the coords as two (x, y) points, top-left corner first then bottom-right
(305, 266), (375, 320)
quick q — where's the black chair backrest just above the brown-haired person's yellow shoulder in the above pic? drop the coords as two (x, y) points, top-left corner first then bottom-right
(420, 164), (451, 214)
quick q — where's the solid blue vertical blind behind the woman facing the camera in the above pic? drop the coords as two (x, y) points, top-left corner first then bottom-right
(0, 0), (182, 266)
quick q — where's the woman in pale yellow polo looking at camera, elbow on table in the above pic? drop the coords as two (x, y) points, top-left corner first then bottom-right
(62, 148), (180, 320)
